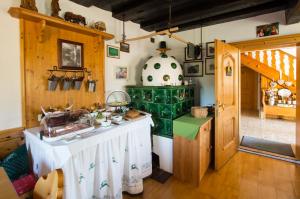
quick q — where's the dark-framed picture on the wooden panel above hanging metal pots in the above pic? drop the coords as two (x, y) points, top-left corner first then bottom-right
(58, 39), (84, 70)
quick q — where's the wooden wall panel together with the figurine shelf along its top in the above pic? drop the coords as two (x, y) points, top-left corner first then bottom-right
(8, 7), (114, 127)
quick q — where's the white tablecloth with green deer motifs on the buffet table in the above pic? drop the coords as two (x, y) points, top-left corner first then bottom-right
(25, 116), (153, 199)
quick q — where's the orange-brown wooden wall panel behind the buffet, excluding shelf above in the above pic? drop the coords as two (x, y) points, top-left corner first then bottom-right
(24, 20), (109, 127)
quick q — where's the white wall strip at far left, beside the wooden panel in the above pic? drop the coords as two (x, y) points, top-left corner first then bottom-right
(0, 1), (21, 130)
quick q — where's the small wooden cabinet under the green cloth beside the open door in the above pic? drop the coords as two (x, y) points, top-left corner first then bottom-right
(173, 120), (212, 186)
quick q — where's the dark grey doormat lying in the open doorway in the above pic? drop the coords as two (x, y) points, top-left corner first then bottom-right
(241, 136), (295, 157)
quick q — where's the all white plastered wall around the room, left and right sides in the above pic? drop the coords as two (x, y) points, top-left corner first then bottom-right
(0, 0), (300, 130)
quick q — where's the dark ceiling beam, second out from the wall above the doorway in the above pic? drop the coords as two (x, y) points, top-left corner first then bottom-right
(141, 0), (278, 31)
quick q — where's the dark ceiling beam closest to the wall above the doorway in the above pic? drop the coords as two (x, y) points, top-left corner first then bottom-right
(177, 2), (287, 31)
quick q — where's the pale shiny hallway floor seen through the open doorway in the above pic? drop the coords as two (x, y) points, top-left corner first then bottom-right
(240, 111), (296, 145)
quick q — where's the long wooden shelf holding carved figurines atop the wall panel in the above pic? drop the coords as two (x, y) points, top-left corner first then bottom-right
(8, 7), (114, 40)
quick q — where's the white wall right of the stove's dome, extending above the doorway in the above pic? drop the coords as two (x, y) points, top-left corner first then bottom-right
(161, 11), (300, 105)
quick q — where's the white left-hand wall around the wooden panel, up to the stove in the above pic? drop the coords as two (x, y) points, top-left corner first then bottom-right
(0, 0), (157, 130)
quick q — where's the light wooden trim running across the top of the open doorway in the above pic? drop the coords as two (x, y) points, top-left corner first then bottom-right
(230, 34), (300, 52)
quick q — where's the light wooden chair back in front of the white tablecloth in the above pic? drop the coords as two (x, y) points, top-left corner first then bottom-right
(33, 169), (64, 199)
